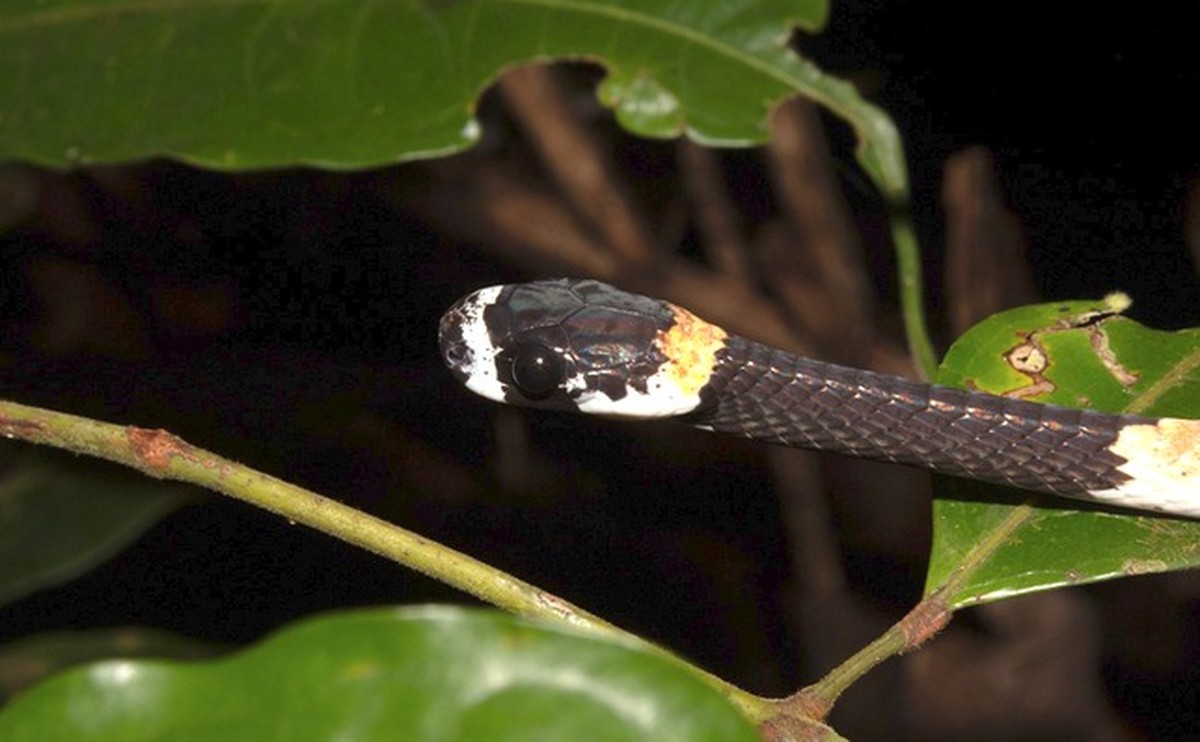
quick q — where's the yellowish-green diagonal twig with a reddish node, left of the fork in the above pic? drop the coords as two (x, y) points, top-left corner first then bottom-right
(0, 400), (772, 722)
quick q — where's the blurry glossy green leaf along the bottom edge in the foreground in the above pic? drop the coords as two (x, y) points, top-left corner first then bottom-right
(0, 609), (757, 742)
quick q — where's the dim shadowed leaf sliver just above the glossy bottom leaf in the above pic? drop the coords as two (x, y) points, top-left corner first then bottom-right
(0, 627), (220, 705)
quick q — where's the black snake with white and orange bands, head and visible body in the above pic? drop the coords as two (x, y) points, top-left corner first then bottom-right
(438, 279), (1200, 519)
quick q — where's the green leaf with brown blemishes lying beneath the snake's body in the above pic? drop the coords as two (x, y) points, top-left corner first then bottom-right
(925, 297), (1200, 608)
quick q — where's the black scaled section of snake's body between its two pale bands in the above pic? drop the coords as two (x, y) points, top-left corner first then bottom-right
(691, 336), (1132, 496)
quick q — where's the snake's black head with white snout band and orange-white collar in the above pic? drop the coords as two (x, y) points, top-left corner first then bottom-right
(439, 279), (724, 418)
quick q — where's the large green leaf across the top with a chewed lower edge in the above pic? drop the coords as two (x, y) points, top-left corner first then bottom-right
(0, 0), (907, 196)
